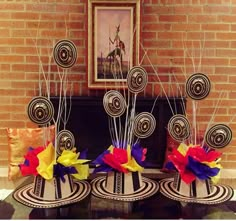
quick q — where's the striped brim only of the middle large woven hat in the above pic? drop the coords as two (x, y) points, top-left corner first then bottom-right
(91, 176), (160, 201)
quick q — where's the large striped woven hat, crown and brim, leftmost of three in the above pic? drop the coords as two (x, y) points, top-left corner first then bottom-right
(13, 175), (91, 208)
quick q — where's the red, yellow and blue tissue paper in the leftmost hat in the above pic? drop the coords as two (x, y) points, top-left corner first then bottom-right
(19, 143), (89, 182)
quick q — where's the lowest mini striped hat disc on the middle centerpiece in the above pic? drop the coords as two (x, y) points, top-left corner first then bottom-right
(134, 112), (156, 138)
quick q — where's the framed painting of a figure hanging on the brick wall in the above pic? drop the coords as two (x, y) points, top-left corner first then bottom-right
(87, 0), (140, 89)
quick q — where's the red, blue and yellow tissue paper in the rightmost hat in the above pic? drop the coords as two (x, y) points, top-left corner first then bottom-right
(165, 143), (222, 184)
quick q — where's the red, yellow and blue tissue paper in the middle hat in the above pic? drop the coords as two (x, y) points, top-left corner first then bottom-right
(92, 143), (147, 173)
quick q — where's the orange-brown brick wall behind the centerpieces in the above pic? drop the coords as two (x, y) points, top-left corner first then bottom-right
(0, 0), (236, 169)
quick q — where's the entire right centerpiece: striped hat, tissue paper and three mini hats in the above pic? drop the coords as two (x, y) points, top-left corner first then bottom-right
(160, 73), (234, 204)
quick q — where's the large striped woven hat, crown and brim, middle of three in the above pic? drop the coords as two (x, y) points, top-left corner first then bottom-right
(91, 172), (159, 201)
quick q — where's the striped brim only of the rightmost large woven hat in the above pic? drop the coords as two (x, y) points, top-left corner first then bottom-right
(160, 178), (234, 204)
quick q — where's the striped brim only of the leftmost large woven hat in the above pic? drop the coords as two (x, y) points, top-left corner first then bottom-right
(13, 180), (91, 208)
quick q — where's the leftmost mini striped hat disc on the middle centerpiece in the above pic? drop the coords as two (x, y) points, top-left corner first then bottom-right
(103, 90), (126, 117)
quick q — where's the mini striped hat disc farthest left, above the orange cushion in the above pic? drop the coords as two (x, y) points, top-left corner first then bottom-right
(27, 97), (54, 125)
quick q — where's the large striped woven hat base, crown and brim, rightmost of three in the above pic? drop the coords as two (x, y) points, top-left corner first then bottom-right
(160, 173), (234, 204)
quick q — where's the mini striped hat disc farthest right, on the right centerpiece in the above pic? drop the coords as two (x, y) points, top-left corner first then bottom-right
(205, 124), (232, 149)
